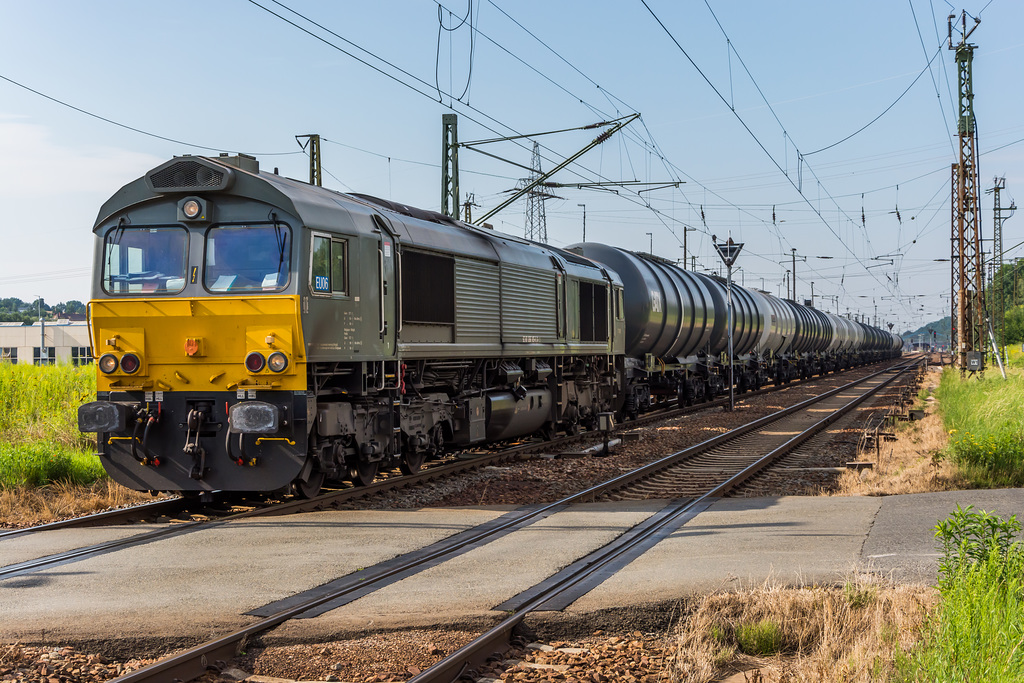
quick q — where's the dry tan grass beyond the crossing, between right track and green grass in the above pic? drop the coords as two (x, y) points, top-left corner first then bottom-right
(827, 368), (971, 496)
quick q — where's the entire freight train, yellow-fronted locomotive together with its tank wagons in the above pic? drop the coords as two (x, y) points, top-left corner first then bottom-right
(79, 155), (902, 496)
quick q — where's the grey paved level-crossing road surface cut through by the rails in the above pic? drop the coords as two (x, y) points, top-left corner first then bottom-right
(0, 489), (1024, 644)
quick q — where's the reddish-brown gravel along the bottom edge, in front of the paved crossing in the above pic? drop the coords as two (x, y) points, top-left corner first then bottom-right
(0, 630), (671, 683)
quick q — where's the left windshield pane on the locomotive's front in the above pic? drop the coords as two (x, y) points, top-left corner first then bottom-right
(102, 226), (188, 294)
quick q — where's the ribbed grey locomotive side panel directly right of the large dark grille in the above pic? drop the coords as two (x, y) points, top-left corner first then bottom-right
(455, 258), (501, 344)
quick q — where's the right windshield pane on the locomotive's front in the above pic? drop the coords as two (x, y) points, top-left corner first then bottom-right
(203, 223), (292, 292)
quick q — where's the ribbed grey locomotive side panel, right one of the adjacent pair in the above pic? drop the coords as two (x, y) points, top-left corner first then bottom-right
(502, 263), (557, 344)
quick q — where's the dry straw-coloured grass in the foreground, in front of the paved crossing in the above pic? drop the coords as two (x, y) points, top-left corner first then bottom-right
(672, 582), (937, 683)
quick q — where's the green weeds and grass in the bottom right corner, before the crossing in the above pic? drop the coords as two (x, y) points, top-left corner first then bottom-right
(898, 508), (1024, 683)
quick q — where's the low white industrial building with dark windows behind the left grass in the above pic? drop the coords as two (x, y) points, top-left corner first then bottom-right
(0, 321), (92, 366)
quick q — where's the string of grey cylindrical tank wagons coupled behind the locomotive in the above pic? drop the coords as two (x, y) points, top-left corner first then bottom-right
(569, 243), (902, 415)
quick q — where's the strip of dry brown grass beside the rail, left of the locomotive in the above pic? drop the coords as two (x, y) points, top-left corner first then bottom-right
(0, 479), (153, 527)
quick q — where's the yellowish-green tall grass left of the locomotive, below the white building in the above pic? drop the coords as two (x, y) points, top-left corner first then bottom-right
(0, 364), (104, 488)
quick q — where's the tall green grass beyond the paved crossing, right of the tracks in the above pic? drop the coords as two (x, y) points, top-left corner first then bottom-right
(938, 370), (1024, 488)
